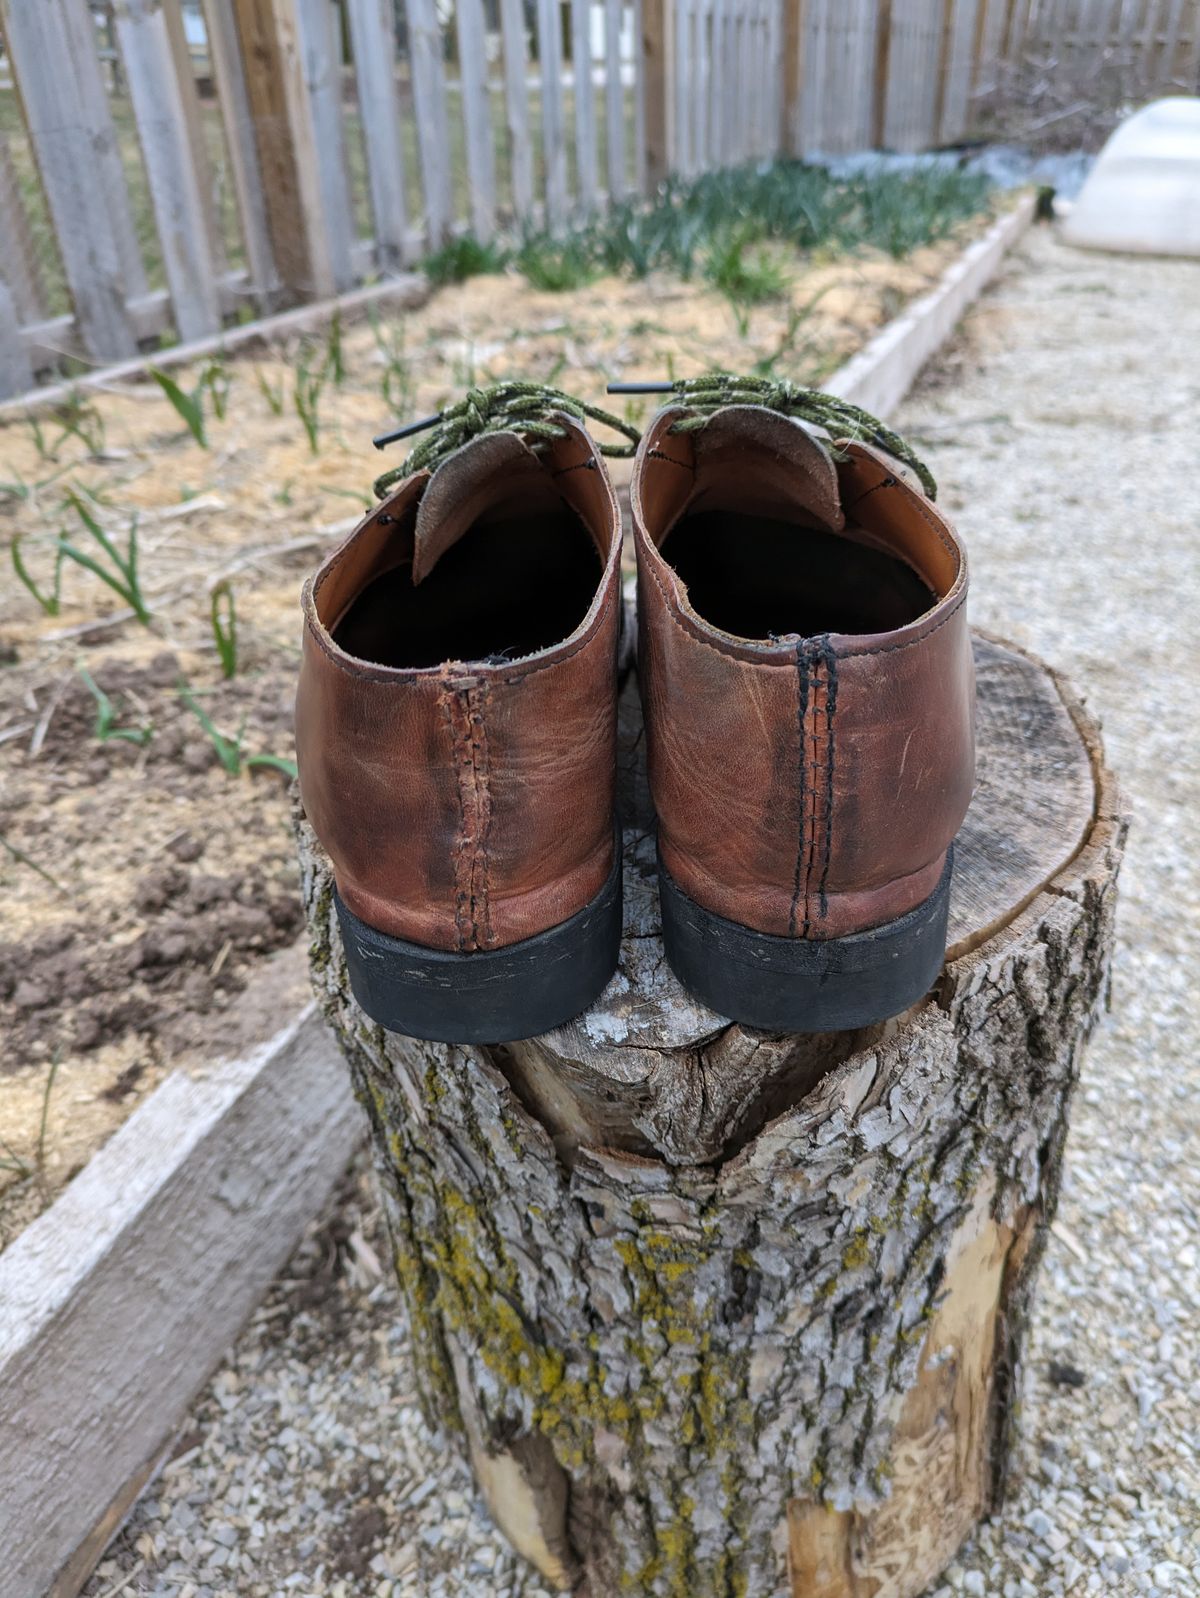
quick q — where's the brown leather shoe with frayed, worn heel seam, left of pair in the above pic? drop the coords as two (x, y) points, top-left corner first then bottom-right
(296, 385), (622, 1042)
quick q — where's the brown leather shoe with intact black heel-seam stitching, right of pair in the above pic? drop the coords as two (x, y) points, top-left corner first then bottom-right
(633, 377), (975, 1031)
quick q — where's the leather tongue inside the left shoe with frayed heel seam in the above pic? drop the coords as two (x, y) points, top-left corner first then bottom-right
(412, 433), (559, 583)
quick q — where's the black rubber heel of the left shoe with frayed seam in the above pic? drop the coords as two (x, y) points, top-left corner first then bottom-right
(334, 842), (622, 1043)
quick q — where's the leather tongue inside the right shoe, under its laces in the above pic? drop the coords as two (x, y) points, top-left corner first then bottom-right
(685, 404), (845, 532)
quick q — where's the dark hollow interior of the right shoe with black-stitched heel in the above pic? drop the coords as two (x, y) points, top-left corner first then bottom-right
(662, 510), (936, 639)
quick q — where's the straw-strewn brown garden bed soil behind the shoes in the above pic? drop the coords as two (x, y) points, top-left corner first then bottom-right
(0, 217), (987, 1248)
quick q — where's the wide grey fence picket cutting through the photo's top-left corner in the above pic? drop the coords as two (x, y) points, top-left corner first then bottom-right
(0, 0), (136, 361)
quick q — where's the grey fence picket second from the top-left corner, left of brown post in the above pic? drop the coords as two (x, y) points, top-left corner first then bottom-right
(117, 0), (221, 344)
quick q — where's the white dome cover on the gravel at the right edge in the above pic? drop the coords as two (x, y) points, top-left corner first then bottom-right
(1063, 96), (1200, 256)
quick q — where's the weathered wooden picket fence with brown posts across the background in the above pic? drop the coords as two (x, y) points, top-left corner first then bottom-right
(0, 0), (1200, 395)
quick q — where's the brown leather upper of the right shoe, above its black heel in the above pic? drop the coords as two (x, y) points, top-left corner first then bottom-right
(633, 406), (975, 938)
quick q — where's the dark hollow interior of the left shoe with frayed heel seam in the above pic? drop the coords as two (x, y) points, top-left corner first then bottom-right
(332, 507), (602, 668)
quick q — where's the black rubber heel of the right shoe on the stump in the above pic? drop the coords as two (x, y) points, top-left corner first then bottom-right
(658, 850), (954, 1032)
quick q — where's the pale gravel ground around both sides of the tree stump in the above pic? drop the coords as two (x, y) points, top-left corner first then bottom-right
(86, 230), (1200, 1598)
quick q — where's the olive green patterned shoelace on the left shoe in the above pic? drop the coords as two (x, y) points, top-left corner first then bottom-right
(375, 382), (641, 499)
